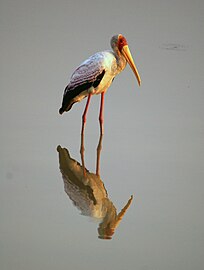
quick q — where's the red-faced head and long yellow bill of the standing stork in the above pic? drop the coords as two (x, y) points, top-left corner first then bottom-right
(111, 34), (141, 85)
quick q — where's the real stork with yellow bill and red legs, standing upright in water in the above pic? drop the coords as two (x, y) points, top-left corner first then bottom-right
(59, 34), (141, 134)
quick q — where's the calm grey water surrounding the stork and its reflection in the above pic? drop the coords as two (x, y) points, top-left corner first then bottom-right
(0, 0), (204, 270)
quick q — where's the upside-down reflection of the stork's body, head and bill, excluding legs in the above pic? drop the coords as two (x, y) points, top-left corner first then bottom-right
(57, 140), (133, 239)
